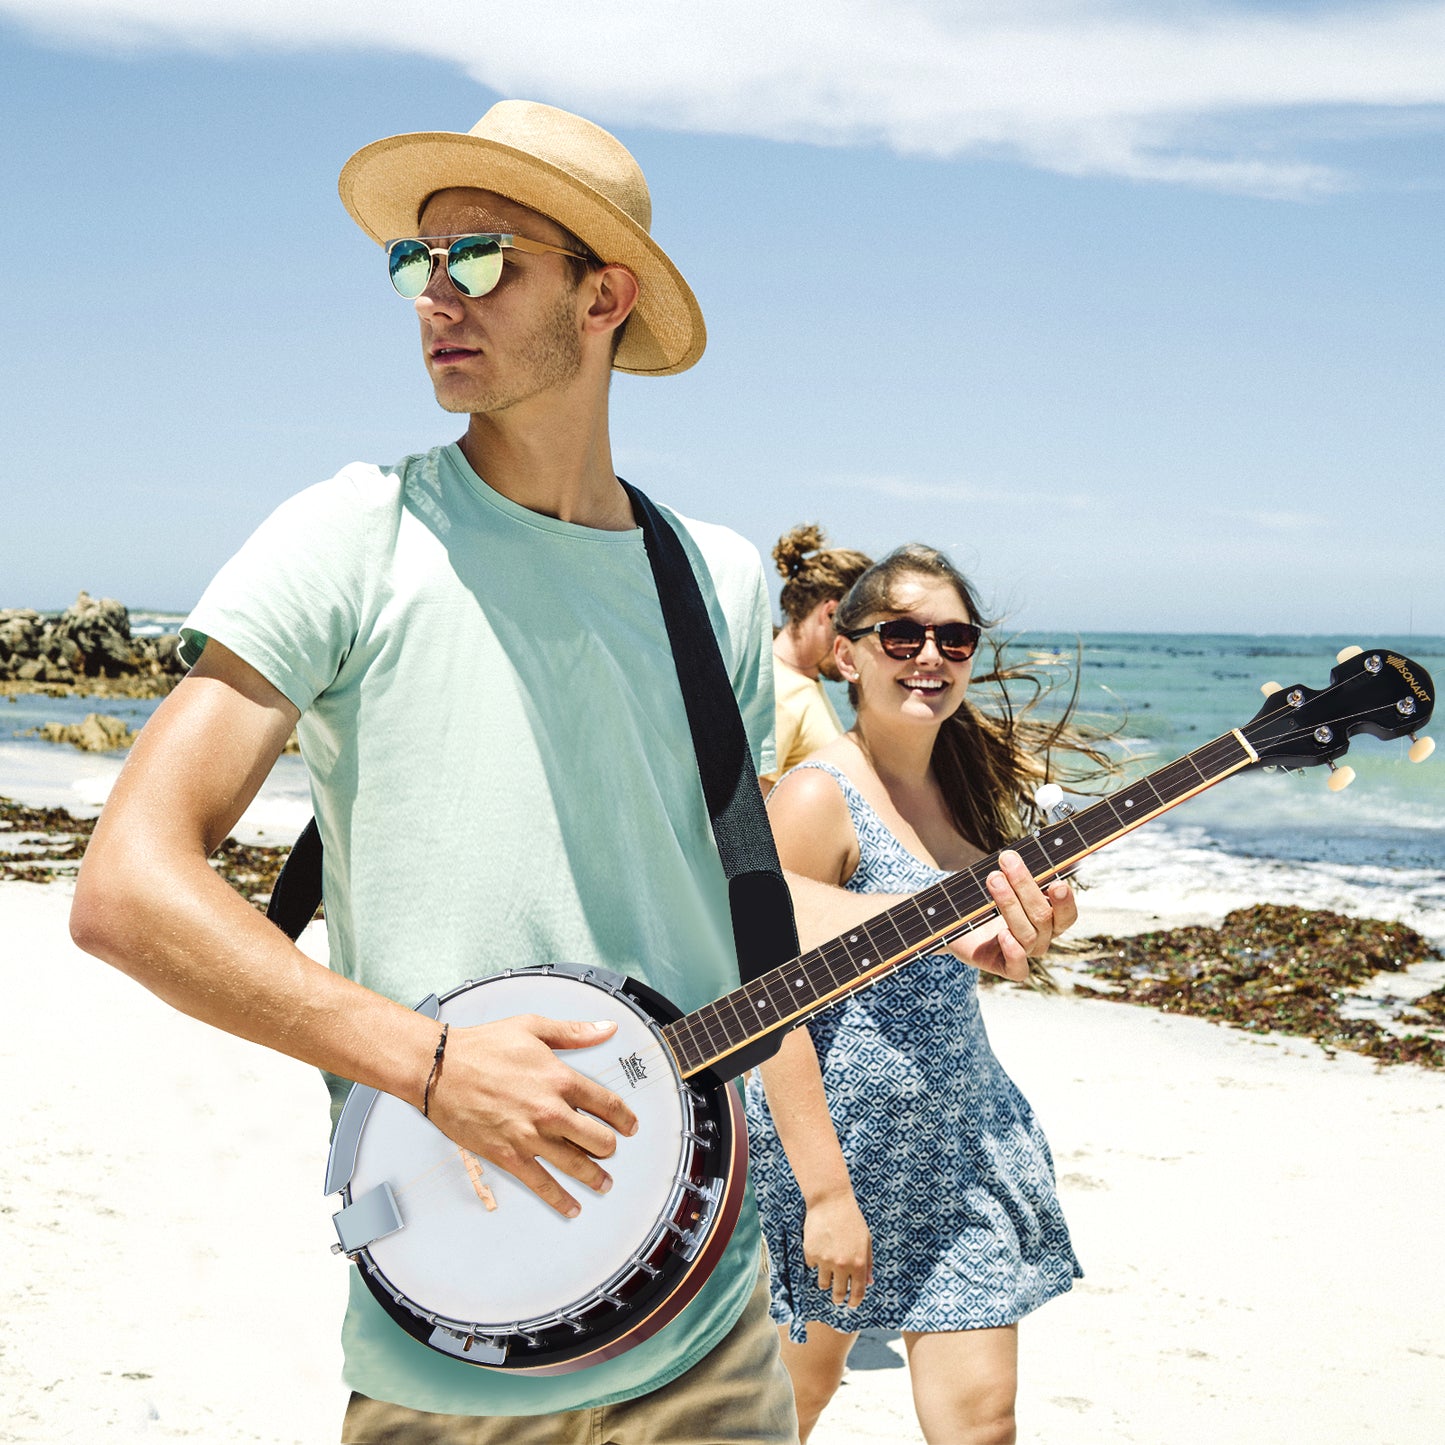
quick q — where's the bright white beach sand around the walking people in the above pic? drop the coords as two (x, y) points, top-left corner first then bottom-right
(0, 883), (1445, 1445)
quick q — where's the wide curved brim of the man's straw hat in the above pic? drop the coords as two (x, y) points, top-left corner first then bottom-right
(340, 130), (707, 376)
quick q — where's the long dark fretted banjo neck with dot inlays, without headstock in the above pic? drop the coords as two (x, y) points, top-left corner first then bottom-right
(662, 730), (1259, 1078)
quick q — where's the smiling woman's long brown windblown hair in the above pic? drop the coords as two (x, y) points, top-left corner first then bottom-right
(832, 542), (1120, 853)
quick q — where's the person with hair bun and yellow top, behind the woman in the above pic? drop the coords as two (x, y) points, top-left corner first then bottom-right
(762, 522), (873, 795)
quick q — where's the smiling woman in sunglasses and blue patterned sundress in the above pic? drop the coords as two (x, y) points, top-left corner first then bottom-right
(749, 543), (1116, 1445)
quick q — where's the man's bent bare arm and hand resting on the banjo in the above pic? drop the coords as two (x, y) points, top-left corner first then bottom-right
(71, 642), (636, 1214)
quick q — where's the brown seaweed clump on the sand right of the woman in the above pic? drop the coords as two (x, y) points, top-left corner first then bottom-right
(1075, 903), (1445, 1068)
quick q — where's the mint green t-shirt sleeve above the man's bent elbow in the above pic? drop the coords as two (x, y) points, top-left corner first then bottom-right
(181, 473), (374, 712)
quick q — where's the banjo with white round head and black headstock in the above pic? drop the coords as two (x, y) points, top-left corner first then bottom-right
(327, 647), (1433, 1374)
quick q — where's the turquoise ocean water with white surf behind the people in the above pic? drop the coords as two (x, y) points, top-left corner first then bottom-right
(0, 627), (1445, 944)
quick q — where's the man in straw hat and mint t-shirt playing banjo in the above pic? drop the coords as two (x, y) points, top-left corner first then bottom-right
(72, 101), (796, 1445)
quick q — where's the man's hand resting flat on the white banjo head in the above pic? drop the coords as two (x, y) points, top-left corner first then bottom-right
(431, 1014), (637, 1220)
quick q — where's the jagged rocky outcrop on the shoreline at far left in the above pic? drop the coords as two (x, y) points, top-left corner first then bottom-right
(0, 592), (185, 692)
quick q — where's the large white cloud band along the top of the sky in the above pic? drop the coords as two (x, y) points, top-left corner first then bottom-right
(0, 0), (1445, 197)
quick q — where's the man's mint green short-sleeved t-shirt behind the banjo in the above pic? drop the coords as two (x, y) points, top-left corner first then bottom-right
(182, 447), (773, 1415)
